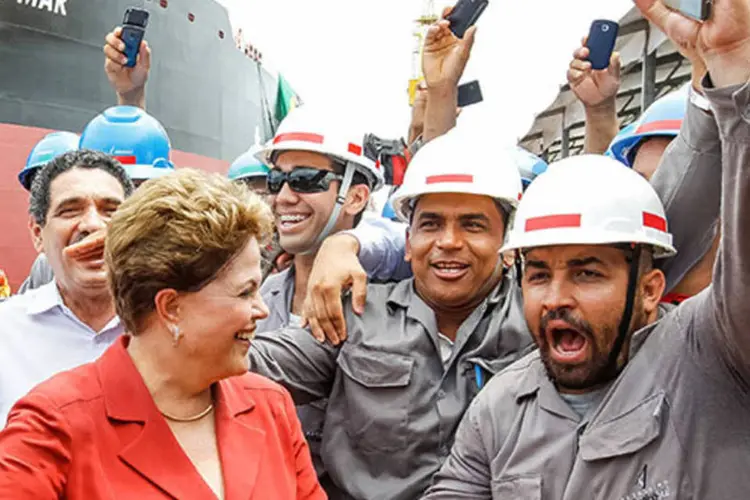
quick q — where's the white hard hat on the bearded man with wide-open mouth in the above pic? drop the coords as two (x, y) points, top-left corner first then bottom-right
(501, 155), (677, 258)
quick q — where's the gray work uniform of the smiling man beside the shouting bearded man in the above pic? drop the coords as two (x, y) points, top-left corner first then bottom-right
(250, 277), (532, 500)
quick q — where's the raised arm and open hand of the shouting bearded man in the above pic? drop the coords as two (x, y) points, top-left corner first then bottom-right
(636, 0), (750, 376)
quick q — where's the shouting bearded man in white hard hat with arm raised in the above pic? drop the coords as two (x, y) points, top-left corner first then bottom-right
(425, 0), (750, 494)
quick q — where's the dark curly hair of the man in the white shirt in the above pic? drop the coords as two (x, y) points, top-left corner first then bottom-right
(29, 149), (134, 226)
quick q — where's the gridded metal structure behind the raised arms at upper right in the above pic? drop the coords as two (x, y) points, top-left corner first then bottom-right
(519, 8), (691, 162)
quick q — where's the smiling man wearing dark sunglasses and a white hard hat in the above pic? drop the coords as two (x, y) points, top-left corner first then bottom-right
(257, 105), (383, 496)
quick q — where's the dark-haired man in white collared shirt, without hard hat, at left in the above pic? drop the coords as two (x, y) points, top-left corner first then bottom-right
(0, 151), (133, 427)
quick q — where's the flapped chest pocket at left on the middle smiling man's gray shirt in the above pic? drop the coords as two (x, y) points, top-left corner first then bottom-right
(337, 346), (414, 453)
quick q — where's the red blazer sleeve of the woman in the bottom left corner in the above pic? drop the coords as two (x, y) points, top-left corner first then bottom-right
(0, 392), (72, 500)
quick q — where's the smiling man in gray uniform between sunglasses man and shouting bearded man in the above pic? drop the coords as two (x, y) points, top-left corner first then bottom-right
(250, 129), (531, 500)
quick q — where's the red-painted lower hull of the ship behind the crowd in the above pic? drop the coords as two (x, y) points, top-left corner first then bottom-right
(0, 123), (229, 291)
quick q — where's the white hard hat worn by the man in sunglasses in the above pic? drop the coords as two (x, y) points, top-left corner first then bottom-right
(258, 105), (385, 191)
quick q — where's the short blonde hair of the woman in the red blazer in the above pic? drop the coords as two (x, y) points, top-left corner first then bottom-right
(105, 169), (273, 333)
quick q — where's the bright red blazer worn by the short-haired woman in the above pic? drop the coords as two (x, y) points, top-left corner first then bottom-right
(0, 336), (326, 500)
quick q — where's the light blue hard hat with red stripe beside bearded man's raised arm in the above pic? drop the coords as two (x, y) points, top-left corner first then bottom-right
(609, 83), (690, 167)
